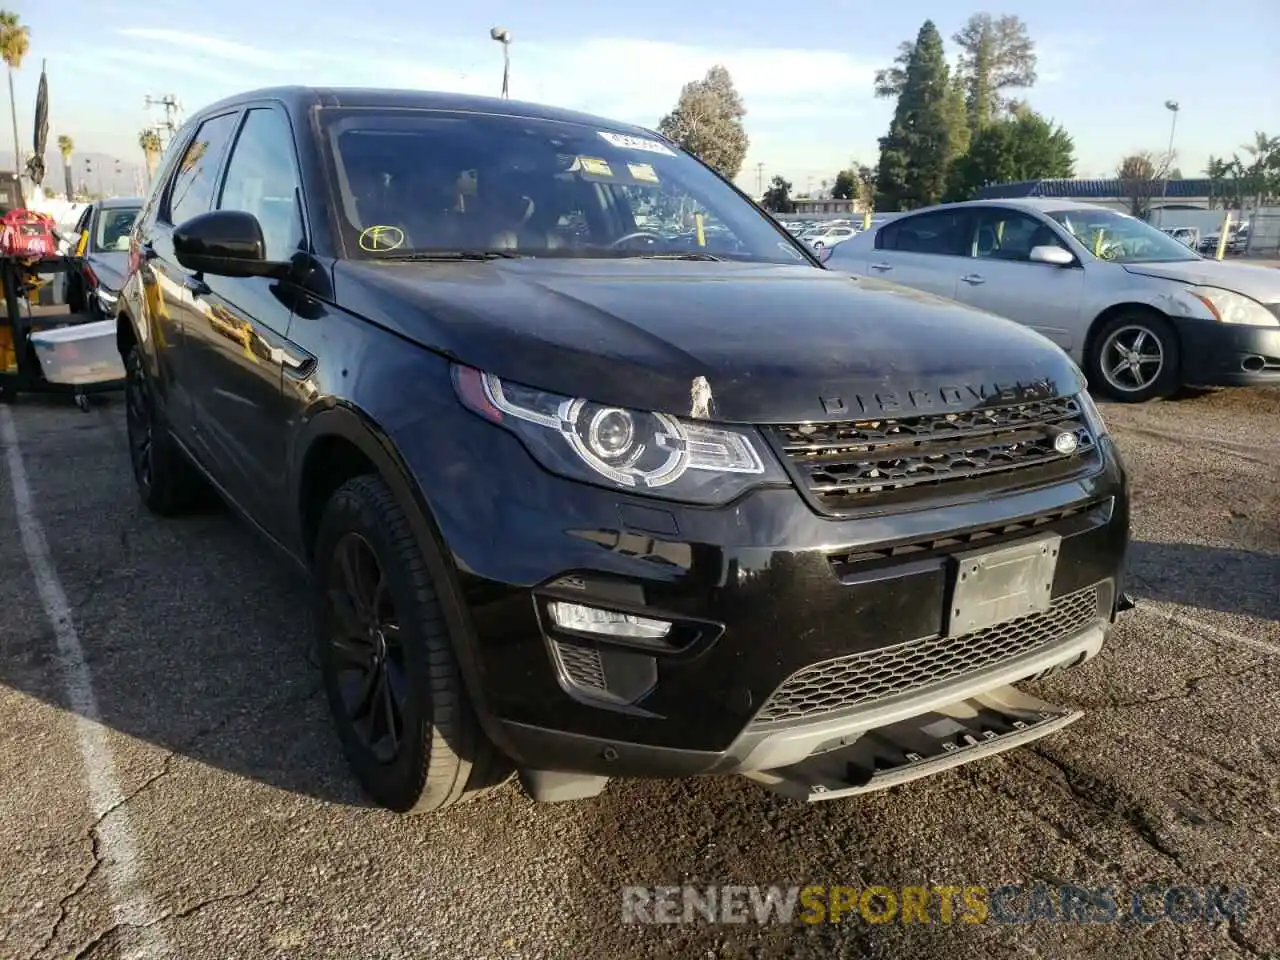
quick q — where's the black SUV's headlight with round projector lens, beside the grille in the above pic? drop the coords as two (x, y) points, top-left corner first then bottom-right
(453, 364), (790, 503)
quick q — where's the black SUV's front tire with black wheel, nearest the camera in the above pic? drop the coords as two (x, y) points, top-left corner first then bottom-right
(314, 475), (511, 814)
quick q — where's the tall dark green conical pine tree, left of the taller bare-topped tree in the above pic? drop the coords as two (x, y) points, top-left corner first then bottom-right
(876, 20), (957, 210)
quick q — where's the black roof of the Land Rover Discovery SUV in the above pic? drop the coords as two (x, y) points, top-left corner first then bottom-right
(197, 87), (666, 140)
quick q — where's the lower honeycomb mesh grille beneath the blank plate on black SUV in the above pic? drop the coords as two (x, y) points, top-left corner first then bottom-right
(755, 586), (1098, 723)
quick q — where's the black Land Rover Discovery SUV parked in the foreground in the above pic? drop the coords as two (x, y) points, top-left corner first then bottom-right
(112, 88), (1129, 812)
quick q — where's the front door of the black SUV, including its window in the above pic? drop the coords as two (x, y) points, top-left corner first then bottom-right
(184, 106), (306, 539)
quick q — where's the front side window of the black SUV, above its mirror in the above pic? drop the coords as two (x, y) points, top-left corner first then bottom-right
(218, 109), (303, 260)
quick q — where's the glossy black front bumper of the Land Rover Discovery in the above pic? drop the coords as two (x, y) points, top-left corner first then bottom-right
(404, 406), (1129, 777)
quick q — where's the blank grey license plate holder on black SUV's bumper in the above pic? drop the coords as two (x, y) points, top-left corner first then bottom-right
(946, 534), (1062, 636)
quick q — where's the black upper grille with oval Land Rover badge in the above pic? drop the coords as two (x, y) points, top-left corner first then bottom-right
(772, 397), (1098, 513)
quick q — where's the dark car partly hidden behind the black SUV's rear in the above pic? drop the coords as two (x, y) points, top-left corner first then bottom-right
(67, 197), (142, 319)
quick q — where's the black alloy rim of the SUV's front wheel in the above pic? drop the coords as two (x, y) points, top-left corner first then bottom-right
(326, 532), (408, 764)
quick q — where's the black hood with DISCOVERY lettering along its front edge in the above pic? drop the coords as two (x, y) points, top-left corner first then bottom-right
(334, 259), (1083, 424)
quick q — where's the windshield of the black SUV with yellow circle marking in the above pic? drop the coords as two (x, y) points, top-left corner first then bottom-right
(319, 109), (809, 264)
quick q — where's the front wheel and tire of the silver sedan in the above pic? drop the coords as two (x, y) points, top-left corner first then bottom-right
(1085, 310), (1181, 403)
